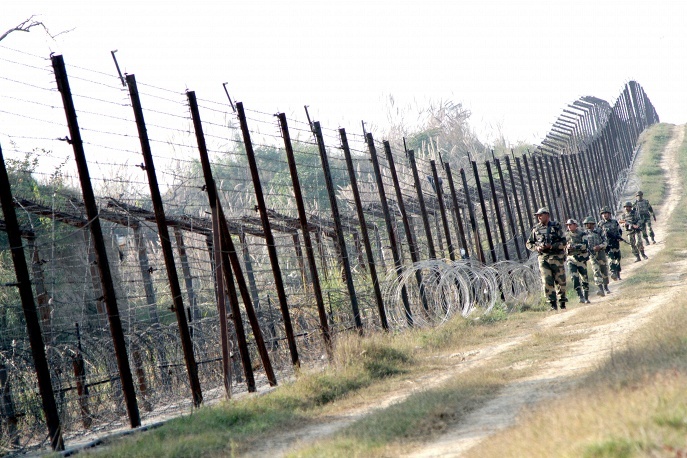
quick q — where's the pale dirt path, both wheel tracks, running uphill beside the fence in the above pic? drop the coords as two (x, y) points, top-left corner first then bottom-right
(244, 126), (687, 458)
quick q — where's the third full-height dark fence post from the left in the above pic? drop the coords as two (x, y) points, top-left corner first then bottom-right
(126, 75), (203, 407)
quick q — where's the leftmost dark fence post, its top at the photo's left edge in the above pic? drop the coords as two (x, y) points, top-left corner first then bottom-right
(0, 144), (64, 451)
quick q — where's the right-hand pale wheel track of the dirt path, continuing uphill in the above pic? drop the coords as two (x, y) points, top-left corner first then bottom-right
(409, 126), (687, 457)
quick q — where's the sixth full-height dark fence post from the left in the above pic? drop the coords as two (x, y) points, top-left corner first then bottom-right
(277, 113), (333, 350)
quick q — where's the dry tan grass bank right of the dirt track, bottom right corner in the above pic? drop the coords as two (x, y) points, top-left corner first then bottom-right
(456, 122), (687, 458)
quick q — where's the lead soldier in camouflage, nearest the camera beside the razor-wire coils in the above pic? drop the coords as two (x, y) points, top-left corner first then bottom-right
(526, 207), (568, 310)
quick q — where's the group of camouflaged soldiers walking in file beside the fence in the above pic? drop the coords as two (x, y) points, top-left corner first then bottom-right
(527, 191), (656, 310)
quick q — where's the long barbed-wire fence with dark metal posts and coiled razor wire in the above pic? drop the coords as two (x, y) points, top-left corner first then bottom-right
(0, 46), (658, 454)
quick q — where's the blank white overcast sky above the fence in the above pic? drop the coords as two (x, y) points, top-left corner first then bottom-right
(0, 0), (687, 144)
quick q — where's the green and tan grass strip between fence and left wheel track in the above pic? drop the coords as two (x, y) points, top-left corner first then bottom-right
(82, 306), (552, 457)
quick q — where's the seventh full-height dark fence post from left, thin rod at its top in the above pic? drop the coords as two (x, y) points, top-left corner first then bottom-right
(313, 121), (363, 332)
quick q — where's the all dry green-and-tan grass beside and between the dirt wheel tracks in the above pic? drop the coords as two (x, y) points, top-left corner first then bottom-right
(79, 122), (687, 457)
